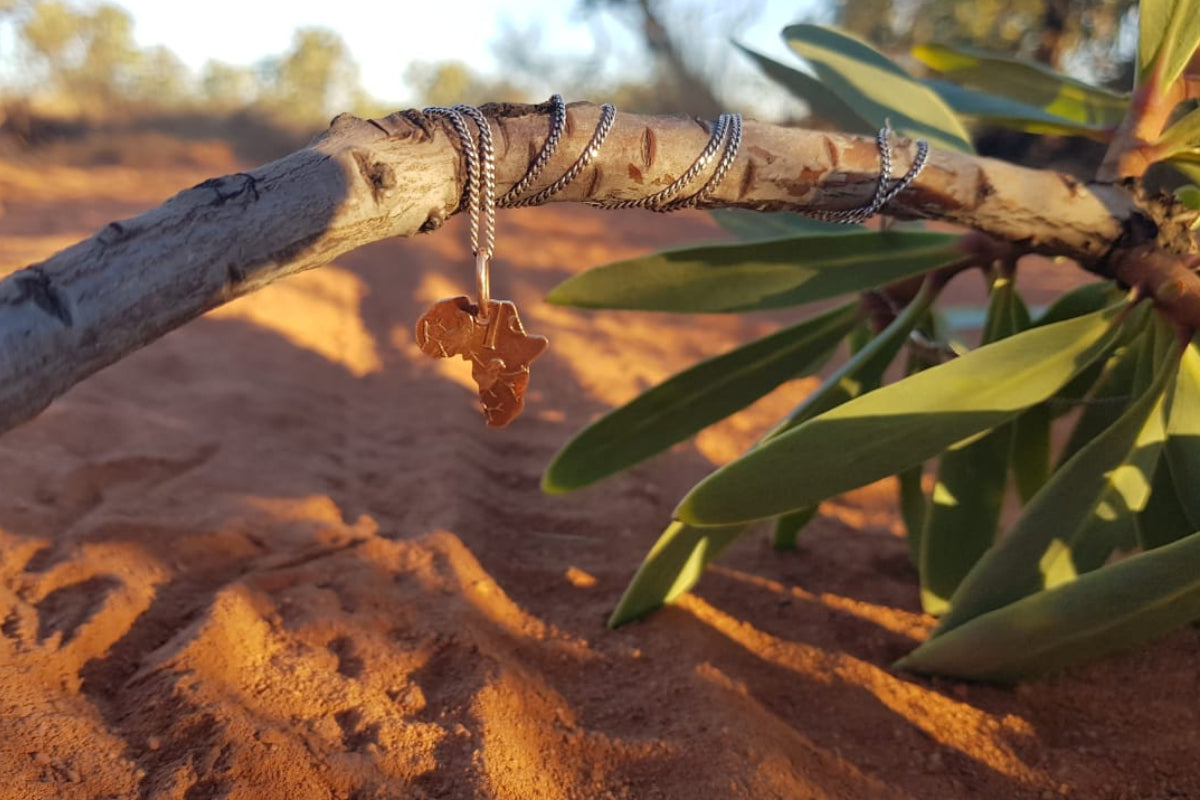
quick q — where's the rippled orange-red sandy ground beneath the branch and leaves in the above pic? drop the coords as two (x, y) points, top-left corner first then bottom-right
(0, 139), (1200, 800)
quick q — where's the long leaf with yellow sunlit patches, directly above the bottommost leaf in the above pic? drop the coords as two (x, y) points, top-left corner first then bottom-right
(934, 331), (1174, 636)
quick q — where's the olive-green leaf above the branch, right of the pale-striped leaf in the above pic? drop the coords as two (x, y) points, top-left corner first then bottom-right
(912, 44), (1129, 133)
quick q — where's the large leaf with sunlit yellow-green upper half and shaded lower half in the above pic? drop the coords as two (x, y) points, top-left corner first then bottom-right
(676, 306), (1120, 525)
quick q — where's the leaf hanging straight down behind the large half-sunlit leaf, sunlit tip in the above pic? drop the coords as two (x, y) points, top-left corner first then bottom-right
(919, 276), (1030, 615)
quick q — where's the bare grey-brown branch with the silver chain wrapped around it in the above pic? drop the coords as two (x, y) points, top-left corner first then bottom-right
(0, 103), (1200, 431)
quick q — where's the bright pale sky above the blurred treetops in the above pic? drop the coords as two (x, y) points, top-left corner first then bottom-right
(113, 0), (818, 102)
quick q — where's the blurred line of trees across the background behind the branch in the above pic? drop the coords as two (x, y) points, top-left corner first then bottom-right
(0, 0), (1136, 151)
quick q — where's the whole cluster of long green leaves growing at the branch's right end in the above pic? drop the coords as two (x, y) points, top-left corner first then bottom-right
(544, 14), (1200, 681)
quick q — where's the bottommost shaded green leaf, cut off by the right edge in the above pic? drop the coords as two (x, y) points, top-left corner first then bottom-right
(895, 525), (1200, 682)
